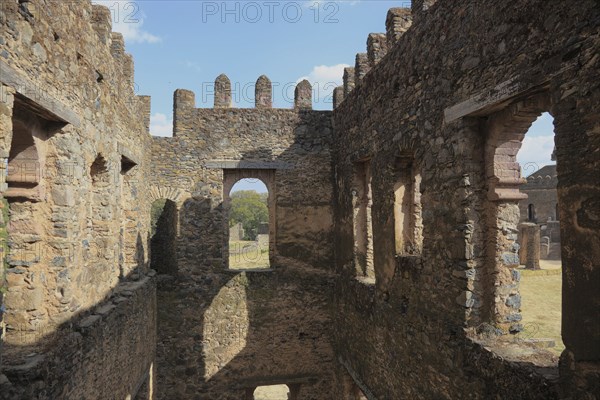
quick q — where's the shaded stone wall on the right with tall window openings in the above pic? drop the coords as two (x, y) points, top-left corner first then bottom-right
(334, 1), (600, 399)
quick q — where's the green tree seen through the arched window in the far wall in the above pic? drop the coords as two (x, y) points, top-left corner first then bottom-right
(229, 190), (269, 240)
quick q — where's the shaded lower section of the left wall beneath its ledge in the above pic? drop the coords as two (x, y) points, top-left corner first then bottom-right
(0, 234), (156, 400)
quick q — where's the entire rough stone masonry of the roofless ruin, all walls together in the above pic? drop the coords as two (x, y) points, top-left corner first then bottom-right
(0, 0), (600, 400)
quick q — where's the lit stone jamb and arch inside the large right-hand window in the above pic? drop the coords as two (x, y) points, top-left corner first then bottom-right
(483, 93), (560, 356)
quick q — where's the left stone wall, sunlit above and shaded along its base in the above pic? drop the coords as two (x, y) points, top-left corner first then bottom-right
(0, 0), (154, 399)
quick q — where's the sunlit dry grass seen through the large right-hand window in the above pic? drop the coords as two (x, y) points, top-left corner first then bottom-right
(520, 270), (565, 354)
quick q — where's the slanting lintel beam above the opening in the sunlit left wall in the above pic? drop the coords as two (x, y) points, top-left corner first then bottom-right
(0, 60), (81, 127)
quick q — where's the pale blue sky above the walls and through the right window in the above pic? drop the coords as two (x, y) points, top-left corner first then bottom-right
(94, 0), (553, 186)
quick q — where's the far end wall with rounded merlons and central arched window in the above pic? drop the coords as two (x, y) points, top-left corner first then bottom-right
(152, 83), (333, 399)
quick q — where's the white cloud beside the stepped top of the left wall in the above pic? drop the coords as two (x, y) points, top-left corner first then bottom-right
(92, 0), (162, 44)
